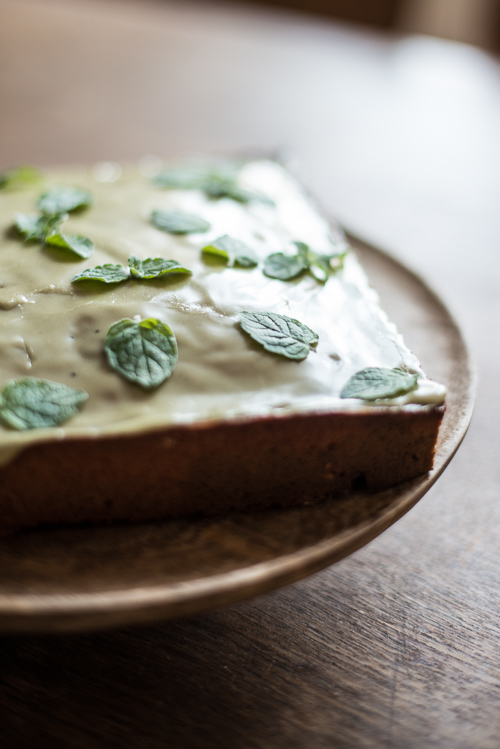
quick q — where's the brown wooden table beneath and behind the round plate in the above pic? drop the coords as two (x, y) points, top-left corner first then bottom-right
(0, 0), (500, 749)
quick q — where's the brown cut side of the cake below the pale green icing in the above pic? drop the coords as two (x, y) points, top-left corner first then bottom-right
(0, 407), (444, 532)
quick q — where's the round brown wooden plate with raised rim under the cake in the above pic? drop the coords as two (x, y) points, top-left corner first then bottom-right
(0, 237), (475, 632)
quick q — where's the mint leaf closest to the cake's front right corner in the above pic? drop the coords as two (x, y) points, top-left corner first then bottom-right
(340, 367), (418, 400)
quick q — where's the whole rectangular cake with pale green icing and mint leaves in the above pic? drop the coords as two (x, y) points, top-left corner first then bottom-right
(0, 160), (445, 532)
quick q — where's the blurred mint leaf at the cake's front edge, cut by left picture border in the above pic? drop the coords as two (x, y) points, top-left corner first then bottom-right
(0, 377), (88, 429)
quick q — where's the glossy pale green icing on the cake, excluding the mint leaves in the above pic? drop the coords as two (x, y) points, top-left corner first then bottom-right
(0, 160), (444, 459)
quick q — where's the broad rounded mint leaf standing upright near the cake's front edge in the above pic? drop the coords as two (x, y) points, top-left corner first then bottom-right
(105, 317), (177, 389)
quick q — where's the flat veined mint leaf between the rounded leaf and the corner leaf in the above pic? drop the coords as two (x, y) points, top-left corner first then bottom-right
(240, 312), (319, 361)
